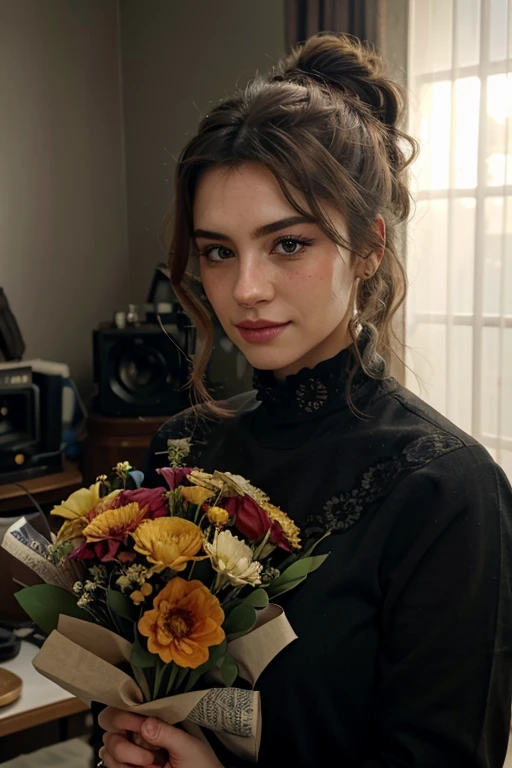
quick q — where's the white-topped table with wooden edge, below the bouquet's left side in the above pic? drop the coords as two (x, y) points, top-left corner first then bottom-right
(0, 641), (88, 737)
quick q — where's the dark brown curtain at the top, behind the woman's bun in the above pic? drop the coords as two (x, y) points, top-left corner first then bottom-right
(284, 0), (386, 52)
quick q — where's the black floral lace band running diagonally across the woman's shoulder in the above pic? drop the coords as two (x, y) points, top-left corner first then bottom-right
(305, 430), (463, 539)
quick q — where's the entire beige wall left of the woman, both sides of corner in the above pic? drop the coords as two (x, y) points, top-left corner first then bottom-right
(0, 0), (284, 396)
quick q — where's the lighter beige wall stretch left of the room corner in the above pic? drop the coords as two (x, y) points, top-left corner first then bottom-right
(0, 0), (129, 395)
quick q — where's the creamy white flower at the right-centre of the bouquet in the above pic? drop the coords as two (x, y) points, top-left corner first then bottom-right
(203, 531), (263, 587)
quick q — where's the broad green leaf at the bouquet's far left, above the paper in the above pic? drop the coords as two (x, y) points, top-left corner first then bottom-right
(15, 584), (92, 635)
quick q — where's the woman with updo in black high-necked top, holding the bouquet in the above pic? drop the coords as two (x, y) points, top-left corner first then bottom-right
(100, 35), (512, 768)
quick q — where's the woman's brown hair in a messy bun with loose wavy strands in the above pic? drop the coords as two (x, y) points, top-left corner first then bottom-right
(164, 33), (417, 413)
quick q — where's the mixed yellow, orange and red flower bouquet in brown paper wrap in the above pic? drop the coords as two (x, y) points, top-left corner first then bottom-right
(2, 441), (327, 761)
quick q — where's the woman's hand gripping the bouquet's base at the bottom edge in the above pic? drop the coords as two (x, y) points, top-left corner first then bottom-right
(98, 707), (222, 768)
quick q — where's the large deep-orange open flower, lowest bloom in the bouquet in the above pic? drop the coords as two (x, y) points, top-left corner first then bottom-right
(138, 576), (225, 669)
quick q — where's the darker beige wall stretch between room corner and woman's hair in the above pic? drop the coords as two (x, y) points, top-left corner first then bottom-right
(120, 0), (284, 302)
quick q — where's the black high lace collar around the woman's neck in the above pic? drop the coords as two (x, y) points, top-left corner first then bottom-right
(254, 347), (373, 424)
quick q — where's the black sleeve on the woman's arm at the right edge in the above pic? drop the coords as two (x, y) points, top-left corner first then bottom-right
(361, 446), (512, 768)
